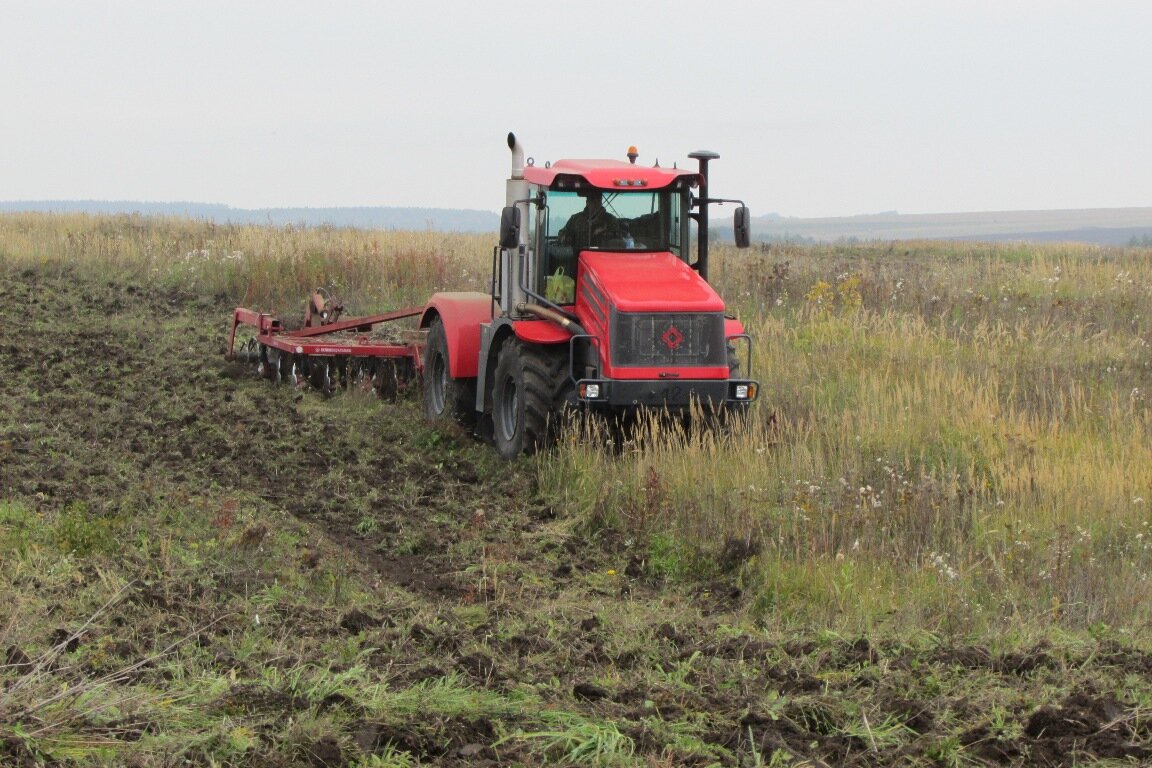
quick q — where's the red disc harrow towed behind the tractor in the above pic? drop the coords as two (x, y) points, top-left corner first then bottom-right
(227, 290), (426, 398)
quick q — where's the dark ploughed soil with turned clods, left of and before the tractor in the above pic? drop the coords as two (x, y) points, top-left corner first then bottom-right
(0, 266), (1152, 766)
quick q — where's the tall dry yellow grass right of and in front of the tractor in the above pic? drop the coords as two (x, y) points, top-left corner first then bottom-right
(541, 244), (1152, 632)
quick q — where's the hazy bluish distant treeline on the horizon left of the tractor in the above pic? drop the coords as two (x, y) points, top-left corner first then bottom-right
(0, 200), (500, 233)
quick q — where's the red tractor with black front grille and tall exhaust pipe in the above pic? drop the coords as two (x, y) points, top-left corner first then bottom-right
(420, 134), (759, 458)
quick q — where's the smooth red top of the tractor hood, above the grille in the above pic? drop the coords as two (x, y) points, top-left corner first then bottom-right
(579, 251), (723, 312)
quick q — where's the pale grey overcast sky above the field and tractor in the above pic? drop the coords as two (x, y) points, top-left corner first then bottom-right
(0, 0), (1152, 216)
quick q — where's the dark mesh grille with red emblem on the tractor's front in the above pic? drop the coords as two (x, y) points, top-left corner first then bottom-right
(612, 312), (728, 367)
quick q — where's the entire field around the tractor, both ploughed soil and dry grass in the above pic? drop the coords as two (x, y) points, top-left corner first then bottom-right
(0, 214), (1152, 767)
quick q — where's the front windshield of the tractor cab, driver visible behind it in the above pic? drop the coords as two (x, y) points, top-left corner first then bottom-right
(546, 189), (684, 258)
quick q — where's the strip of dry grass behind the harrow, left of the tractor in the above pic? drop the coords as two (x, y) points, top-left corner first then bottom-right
(0, 213), (492, 313)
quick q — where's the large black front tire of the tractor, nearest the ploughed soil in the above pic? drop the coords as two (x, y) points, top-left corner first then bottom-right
(492, 339), (575, 458)
